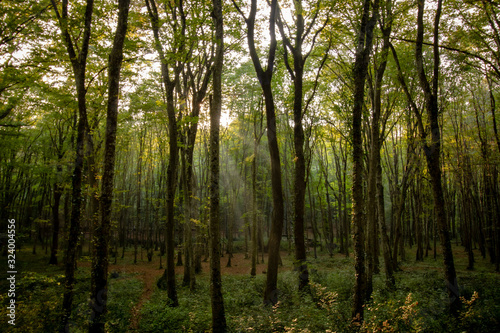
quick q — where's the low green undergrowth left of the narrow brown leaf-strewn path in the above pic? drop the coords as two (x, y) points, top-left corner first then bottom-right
(0, 268), (143, 333)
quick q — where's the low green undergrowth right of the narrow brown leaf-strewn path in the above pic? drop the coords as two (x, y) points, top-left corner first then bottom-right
(139, 254), (500, 332)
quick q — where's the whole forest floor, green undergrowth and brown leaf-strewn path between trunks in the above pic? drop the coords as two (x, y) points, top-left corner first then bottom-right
(0, 241), (500, 332)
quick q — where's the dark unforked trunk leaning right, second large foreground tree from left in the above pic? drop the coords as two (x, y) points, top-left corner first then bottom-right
(89, 0), (130, 333)
